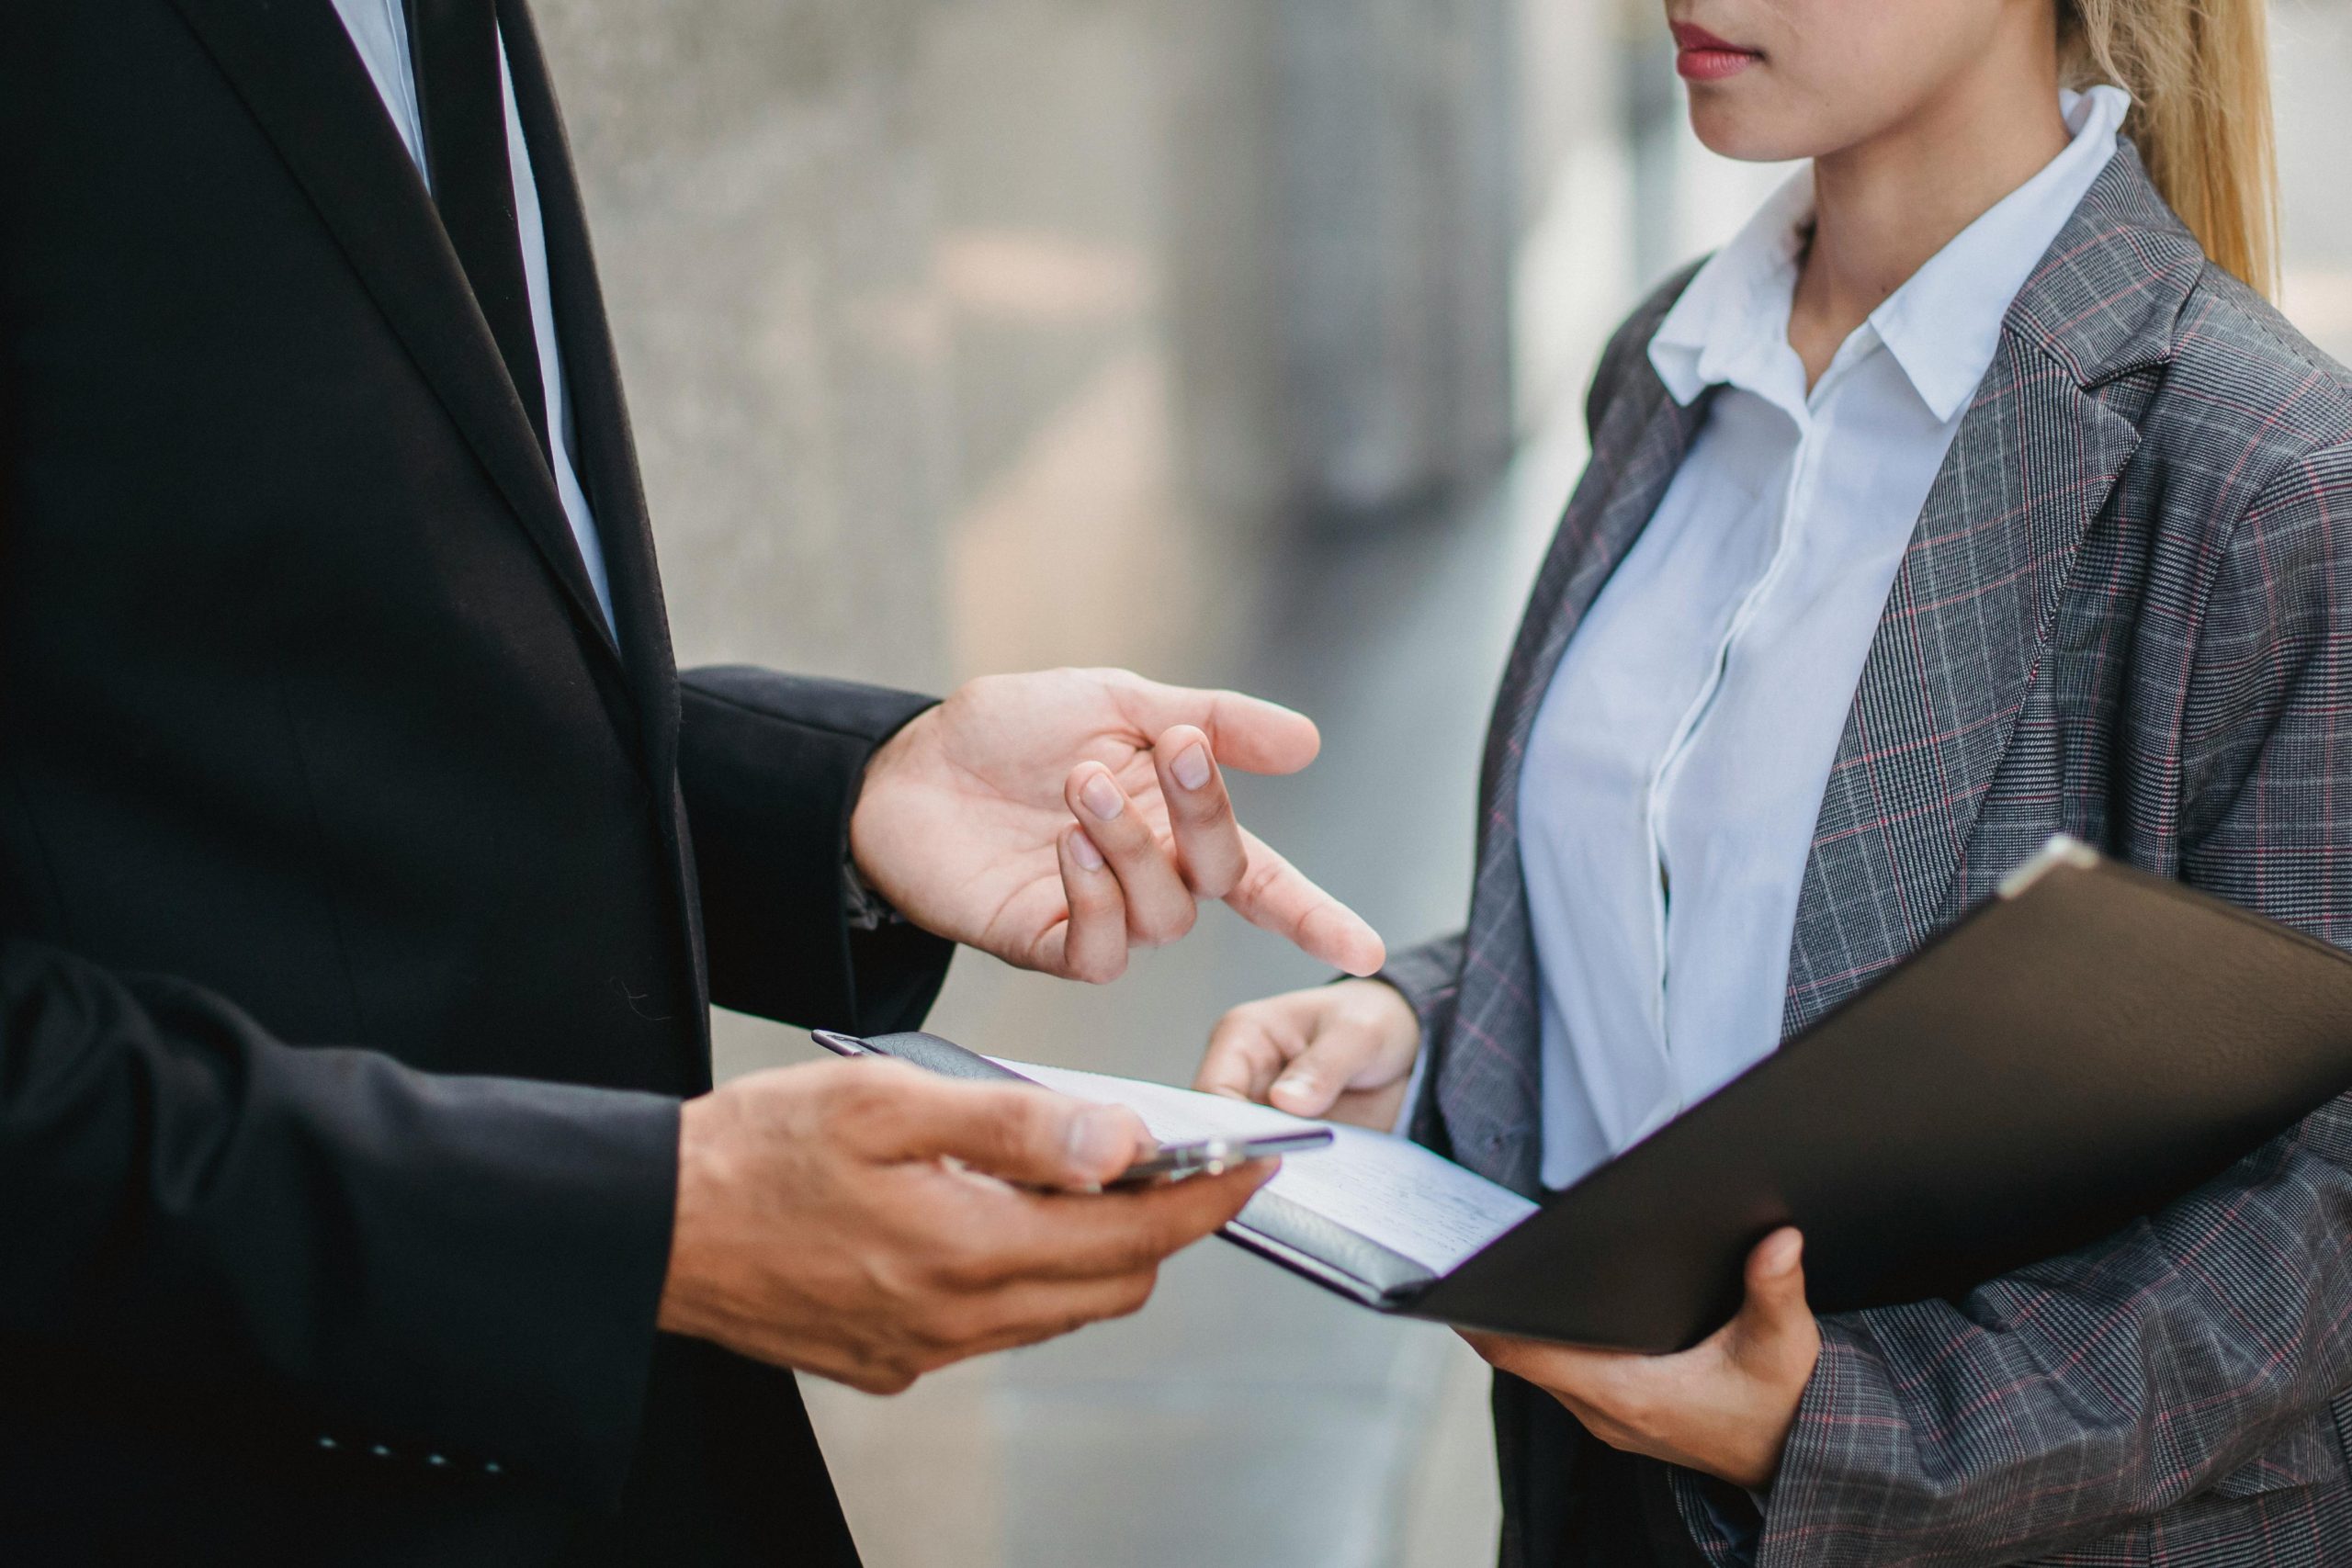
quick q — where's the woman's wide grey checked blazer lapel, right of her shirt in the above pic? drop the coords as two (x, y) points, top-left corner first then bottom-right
(1782, 146), (2201, 1034)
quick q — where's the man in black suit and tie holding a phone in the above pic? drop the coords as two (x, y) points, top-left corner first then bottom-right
(0, 0), (1381, 1563)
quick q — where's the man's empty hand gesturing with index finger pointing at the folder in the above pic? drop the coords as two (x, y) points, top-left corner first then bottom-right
(849, 670), (1383, 983)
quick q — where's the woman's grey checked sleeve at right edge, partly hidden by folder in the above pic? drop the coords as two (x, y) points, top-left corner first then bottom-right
(1677, 446), (2352, 1568)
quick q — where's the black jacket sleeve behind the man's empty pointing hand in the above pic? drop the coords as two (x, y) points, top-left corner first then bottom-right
(677, 665), (955, 1034)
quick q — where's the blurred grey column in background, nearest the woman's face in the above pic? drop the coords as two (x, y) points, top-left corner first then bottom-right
(1164, 0), (1521, 522)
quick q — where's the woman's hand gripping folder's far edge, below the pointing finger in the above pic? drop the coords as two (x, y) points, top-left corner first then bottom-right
(1193, 980), (1420, 1134)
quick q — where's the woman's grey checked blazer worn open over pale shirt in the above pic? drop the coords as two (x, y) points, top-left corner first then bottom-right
(1387, 146), (2352, 1568)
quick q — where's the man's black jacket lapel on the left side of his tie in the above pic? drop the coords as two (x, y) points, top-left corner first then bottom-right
(174, 0), (616, 656)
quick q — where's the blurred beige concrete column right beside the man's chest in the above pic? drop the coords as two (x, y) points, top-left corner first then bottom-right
(532, 0), (955, 686)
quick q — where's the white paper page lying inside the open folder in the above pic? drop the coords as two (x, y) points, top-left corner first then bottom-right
(997, 1060), (1536, 1274)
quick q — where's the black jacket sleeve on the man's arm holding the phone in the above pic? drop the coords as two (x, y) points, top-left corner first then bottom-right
(0, 938), (677, 1505)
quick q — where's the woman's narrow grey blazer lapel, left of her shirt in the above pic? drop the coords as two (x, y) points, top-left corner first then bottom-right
(1437, 376), (1705, 1194)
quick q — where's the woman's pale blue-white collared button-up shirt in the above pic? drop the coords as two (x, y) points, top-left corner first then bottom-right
(1520, 87), (2129, 1187)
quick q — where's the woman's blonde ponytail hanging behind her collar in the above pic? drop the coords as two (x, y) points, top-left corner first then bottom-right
(2058, 0), (2279, 296)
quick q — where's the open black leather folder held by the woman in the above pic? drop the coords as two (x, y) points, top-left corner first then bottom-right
(823, 840), (2352, 1352)
